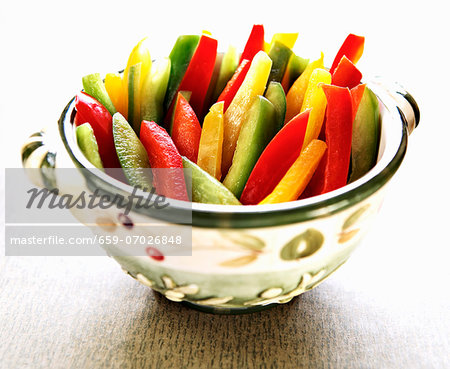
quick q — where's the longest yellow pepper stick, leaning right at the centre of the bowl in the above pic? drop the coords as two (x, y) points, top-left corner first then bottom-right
(222, 51), (272, 175)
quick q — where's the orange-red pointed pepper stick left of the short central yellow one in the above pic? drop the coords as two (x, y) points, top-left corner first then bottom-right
(172, 93), (202, 163)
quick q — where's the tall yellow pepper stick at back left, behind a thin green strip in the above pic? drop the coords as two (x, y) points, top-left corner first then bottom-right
(122, 37), (152, 122)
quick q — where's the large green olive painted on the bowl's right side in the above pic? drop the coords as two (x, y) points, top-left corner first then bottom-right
(280, 228), (324, 260)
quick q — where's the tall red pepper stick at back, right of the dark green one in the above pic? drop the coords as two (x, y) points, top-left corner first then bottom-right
(178, 34), (217, 116)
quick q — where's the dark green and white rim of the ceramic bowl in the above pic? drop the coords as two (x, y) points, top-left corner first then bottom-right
(58, 82), (408, 228)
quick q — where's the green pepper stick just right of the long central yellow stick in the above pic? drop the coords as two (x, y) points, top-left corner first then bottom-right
(223, 96), (277, 198)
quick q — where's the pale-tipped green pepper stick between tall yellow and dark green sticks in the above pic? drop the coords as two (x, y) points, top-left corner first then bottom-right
(141, 58), (170, 125)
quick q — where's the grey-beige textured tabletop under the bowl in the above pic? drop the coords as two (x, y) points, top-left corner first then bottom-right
(0, 255), (449, 369)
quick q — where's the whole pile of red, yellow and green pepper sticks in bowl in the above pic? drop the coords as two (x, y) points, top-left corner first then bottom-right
(75, 25), (379, 205)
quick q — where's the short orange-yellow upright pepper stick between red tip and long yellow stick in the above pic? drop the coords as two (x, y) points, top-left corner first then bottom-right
(197, 101), (224, 181)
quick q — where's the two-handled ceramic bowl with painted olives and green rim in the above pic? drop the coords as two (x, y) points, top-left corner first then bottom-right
(22, 80), (419, 313)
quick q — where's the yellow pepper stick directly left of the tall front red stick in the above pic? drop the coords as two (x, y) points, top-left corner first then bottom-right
(300, 68), (331, 149)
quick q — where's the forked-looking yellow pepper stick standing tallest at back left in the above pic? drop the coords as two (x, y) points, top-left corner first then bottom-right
(123, 38), (152, 121)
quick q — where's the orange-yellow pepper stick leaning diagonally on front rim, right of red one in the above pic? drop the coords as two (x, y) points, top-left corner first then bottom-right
(259, 140), (327, 205)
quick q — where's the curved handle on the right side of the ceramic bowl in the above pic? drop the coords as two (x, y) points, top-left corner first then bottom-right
(369, 77), (420, 135)
